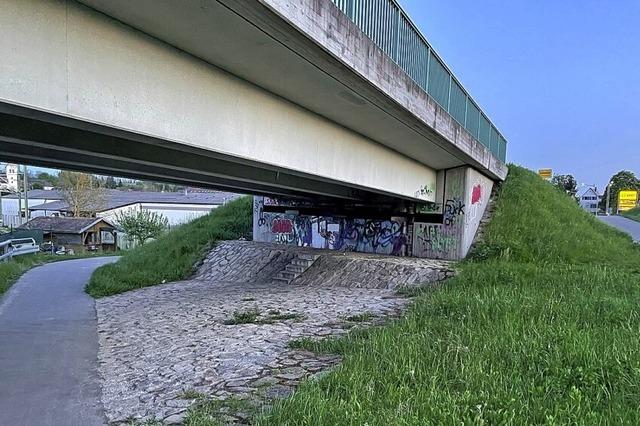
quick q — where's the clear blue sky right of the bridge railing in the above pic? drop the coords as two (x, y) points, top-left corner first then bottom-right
(399, 0), (640, 190)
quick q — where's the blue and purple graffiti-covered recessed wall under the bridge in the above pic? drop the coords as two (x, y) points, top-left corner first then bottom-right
(254, 197), (408, 256)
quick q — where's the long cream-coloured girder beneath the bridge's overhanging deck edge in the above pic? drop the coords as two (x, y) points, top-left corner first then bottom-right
(0, 0), (436, 201)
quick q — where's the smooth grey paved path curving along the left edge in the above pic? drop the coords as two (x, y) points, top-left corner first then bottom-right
(0, 258), (116, 426)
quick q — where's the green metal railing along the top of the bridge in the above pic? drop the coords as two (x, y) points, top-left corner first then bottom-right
(332, 0), (507, 161)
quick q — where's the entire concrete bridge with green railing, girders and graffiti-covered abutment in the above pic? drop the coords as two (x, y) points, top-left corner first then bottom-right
(0, 0), (507, 258)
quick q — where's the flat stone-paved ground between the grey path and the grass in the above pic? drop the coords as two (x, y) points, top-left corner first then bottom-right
(96, 280), (407, 423)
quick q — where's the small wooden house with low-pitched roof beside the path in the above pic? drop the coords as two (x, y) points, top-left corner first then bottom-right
(18, 216), (117, 251)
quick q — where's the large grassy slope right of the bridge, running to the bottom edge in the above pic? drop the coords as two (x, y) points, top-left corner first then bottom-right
(258, 166), (640, 425)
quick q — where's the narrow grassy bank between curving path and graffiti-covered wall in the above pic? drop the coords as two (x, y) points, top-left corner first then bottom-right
(86, 197), (252, 297)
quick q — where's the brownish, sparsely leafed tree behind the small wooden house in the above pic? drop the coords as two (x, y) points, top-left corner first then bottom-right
(58, 171), (106, 217)
